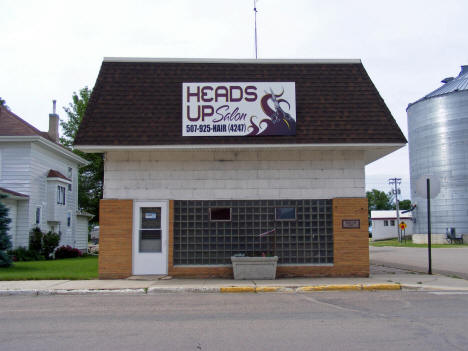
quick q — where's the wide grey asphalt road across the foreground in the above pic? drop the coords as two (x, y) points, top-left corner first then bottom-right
(0, 291), (468, 351)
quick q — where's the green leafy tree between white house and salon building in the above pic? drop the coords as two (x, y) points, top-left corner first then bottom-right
(60, 87), (104, 222)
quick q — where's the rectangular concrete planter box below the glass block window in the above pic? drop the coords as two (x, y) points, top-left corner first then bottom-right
(231, 256), (278, 280)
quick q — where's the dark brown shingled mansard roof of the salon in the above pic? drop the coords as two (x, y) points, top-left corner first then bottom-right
(75, 59), (406, 147)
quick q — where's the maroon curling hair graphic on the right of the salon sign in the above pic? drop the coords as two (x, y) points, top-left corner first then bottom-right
(247, 89), (296, 136)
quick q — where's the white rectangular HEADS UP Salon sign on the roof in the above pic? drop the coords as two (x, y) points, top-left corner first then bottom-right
(182, 82), (296, 136)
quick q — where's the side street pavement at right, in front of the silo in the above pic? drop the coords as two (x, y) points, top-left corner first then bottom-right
(369, 246), (468, 280)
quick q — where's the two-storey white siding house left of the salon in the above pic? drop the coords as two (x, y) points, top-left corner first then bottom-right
(0, 107), (87, 250)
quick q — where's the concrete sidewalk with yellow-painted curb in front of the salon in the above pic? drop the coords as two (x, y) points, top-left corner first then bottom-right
(0, 265), (468, 296)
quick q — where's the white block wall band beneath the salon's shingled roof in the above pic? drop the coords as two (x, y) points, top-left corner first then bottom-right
(104, 150), (365, 200)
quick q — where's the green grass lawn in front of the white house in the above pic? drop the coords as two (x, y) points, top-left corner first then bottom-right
(0, 256), (98, 280)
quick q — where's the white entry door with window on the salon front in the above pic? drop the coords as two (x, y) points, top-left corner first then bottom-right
(133, 201), (168, 275)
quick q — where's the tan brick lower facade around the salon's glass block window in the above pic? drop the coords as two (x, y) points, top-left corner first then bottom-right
(99, 198), (369, 279)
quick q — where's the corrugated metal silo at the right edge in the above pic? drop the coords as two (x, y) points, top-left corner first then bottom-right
(407, 66), (468, 234)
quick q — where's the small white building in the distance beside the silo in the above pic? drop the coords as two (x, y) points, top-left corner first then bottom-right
(371, 210), (413, 241)
